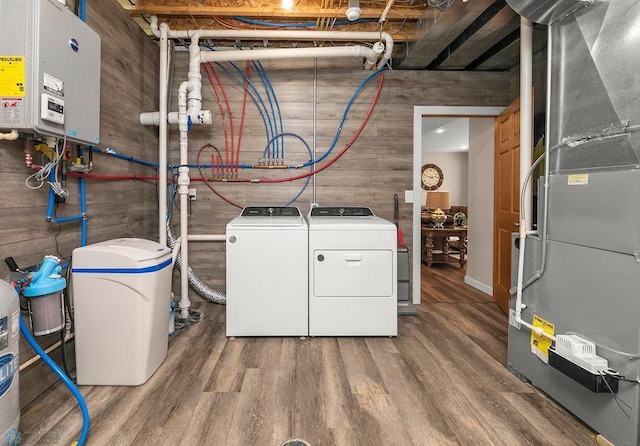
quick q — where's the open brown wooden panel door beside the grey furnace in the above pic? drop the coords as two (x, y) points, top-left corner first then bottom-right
(493, 98), (520, 314)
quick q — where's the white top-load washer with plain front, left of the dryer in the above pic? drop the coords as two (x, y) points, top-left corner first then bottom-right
(226, 206), (309, 336)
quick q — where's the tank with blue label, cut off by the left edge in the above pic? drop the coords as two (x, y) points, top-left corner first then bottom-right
(0, 280), (20, 441)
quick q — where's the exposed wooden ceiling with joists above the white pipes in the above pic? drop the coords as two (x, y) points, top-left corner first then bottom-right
(118, 0), (546, 71)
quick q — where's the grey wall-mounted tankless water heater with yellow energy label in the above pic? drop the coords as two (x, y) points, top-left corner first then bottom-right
(0, 0), (100, 144)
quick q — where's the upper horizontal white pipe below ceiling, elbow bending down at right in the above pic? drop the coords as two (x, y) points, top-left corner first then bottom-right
(150, 16), (393, 69)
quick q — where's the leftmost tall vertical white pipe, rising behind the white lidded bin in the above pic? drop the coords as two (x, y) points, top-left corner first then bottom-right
(157, 23), (169, 246)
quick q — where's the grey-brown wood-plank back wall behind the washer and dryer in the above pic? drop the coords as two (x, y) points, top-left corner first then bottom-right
(169, 55), (511, 300)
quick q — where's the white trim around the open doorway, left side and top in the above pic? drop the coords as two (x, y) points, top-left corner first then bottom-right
(412, 106), (504, 304)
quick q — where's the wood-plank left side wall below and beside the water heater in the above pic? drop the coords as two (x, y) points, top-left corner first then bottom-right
(0, 0), (159, 406)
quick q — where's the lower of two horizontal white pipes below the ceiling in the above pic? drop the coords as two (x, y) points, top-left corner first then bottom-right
(200, 45), (379, 66)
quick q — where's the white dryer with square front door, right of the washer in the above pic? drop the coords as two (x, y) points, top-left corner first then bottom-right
(308, 207), (398, 336)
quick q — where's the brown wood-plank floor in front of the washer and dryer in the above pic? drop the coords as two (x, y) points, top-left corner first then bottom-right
(20, 265), (595, 446)
